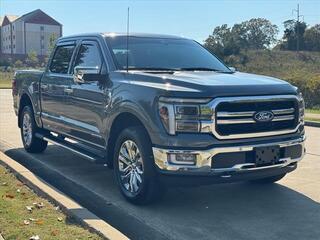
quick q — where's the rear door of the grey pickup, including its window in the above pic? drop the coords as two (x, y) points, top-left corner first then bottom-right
(40, 41), (76, 133)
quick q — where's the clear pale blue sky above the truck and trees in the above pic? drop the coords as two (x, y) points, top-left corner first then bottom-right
(0, 0), (320, 42)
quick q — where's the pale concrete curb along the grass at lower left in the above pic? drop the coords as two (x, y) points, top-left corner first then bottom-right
(0, 152), (129, 240)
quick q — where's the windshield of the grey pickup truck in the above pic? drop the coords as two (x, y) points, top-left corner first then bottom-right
(106, 36), (231, 72)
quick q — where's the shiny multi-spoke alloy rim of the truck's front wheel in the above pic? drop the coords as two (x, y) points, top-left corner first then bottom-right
(118, 140), (143, 193)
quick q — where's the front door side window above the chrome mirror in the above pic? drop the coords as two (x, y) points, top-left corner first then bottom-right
(74, 43), (102, 69)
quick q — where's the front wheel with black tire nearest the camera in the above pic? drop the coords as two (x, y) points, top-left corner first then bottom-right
(113, 127), (164, 205)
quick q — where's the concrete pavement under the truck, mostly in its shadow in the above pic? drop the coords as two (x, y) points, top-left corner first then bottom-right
(0, 90), (320, 240)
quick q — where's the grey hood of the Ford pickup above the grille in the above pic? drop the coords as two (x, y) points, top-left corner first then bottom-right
(124, 71), (296, 97)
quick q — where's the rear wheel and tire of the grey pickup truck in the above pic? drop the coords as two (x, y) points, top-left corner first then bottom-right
(20, 106), (48, 153)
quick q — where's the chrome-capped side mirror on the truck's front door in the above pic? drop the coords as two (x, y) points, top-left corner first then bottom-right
(73, 66), (100, 84)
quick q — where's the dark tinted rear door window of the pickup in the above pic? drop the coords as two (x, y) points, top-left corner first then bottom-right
(50, 45), (74, 73)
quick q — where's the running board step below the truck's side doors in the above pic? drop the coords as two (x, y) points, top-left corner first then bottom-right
(35, 133), (103, 163)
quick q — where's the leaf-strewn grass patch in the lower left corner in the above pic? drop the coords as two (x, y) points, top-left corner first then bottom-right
(0, 166), (102, 240)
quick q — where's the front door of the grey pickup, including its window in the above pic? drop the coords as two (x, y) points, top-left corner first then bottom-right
(62, 40), (110, 148)
